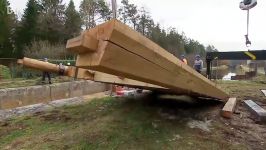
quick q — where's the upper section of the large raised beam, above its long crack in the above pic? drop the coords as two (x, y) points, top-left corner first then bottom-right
(95, 20), (215, 86)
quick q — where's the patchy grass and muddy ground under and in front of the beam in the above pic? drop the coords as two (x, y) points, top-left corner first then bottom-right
(0, 76), (266, 150)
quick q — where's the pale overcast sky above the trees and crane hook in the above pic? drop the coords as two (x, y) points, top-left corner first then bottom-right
(9, 0), (266, 51)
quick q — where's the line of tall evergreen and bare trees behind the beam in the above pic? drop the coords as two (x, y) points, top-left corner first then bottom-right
(0, 0), (217, 58)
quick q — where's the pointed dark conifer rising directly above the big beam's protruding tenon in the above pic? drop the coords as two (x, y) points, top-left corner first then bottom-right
(65, 0), (81, 40)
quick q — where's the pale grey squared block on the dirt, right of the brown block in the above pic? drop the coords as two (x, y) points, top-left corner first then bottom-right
(244, 100), (266, 122)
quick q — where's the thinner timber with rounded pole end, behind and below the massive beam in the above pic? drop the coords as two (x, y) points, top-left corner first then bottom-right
(18, 57), (165, 90)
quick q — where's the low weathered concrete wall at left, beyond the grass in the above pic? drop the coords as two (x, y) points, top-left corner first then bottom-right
(0, 80), (110, 109)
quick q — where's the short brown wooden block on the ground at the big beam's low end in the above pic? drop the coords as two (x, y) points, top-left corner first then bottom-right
(221, 98), (237, 118)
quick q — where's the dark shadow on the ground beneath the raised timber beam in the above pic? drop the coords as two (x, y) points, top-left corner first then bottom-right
(117, 93), (224, 120)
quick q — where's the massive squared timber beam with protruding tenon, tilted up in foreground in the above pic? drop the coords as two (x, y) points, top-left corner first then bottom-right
(66, 19), (228, 100)
